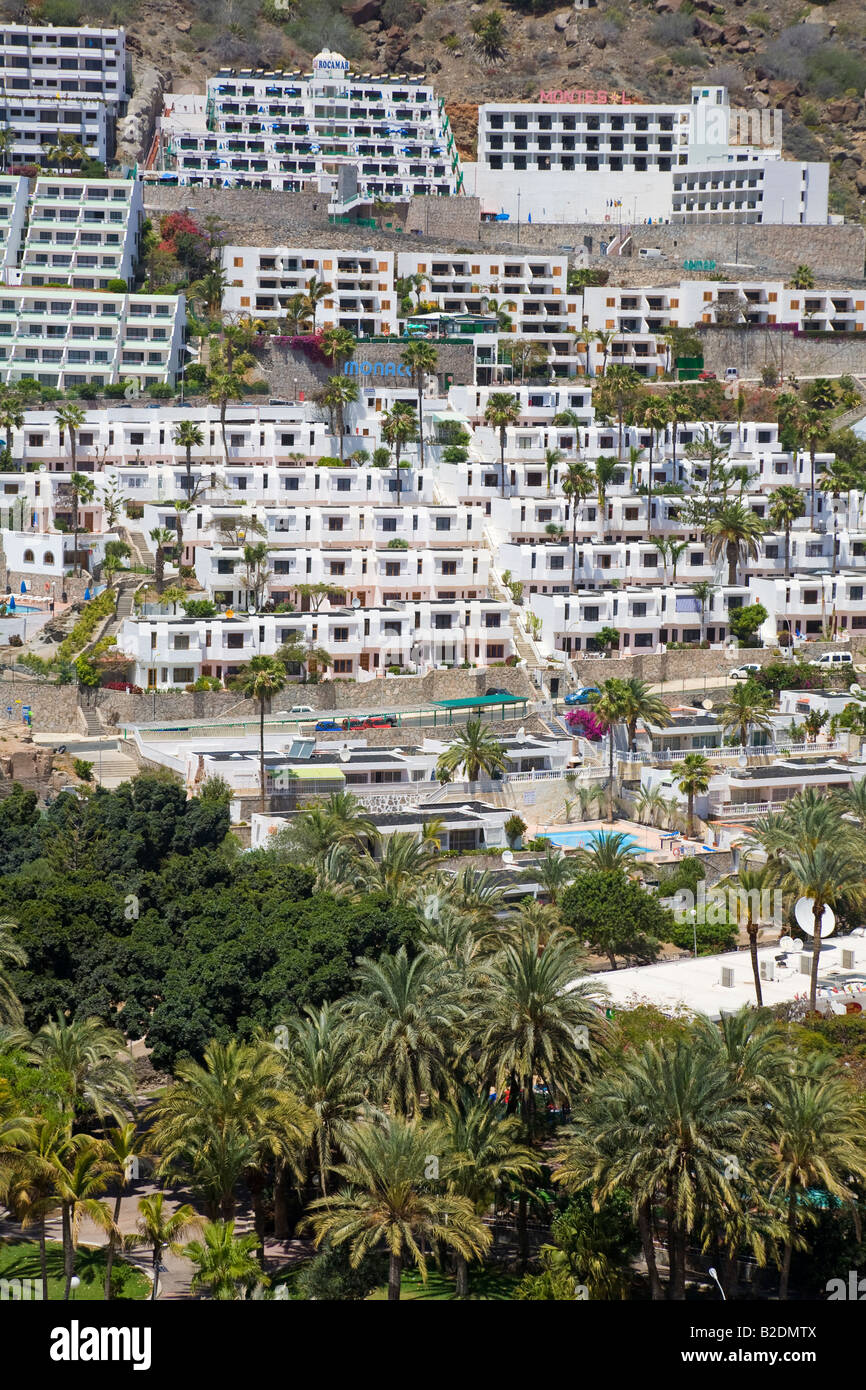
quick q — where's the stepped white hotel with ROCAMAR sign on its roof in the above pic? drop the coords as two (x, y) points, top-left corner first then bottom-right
(157, 50), (463, 202)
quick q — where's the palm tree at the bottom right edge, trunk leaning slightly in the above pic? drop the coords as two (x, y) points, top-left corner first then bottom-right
(766, 1065), (866, 1301)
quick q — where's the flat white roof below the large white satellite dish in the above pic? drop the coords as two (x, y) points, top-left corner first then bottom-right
(584, 937), (866, 1019)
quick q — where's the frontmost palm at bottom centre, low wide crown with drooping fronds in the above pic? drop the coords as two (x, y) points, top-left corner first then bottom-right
(307, 1116), (491, 1302)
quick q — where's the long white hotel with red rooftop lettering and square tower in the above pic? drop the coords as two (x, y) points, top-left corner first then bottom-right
(464, 86), (827, 228)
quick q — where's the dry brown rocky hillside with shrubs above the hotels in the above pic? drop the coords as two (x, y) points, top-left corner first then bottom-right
(10, 0), (866, 217)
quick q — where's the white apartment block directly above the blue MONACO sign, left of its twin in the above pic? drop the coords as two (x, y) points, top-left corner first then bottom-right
(222, 246), (398, 338)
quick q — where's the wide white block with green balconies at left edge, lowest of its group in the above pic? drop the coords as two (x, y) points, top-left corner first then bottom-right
(0, 285), (186, 388)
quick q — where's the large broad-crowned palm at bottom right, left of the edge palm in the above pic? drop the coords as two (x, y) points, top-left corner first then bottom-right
(555, 1038), (755, 1300)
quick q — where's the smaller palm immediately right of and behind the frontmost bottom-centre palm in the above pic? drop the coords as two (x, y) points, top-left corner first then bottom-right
(431, 1087), (539, 1298)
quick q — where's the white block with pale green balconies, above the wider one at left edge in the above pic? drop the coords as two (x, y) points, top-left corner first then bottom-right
(19, 178), (143, 289)
